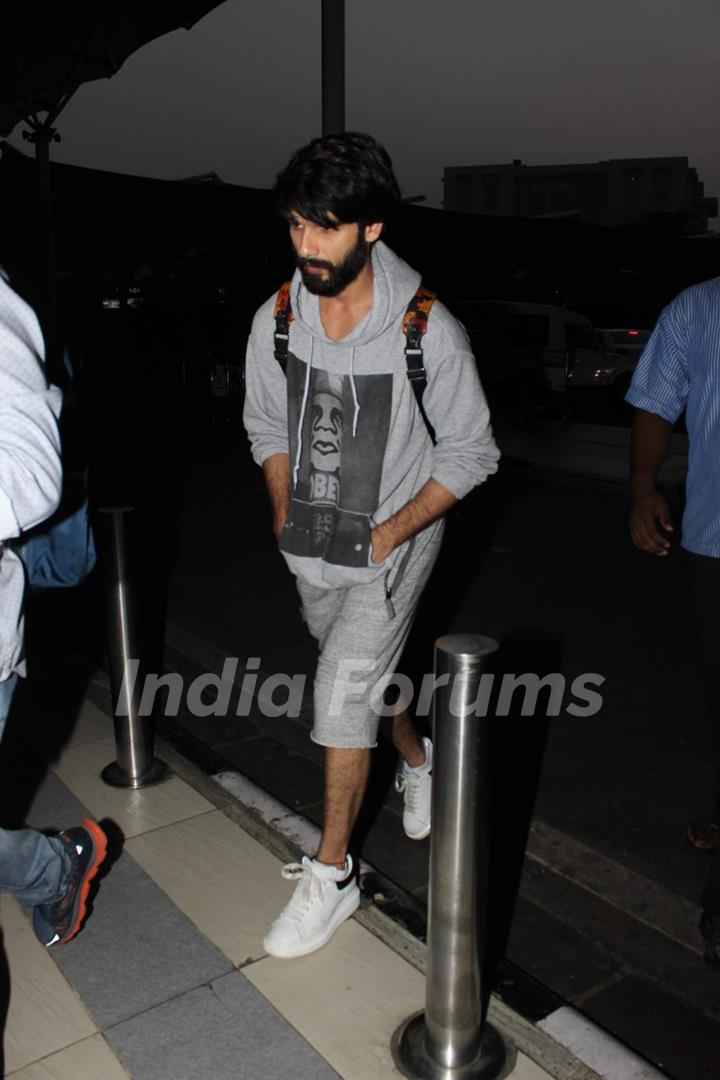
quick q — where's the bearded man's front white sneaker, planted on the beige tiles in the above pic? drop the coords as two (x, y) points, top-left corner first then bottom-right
(262, 855), (361, 959)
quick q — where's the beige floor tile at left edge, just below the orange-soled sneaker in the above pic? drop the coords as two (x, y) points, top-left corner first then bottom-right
(0, 895), (97, 1072)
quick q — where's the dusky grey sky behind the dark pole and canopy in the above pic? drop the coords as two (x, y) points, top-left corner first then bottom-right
(11, 0), (720, 217)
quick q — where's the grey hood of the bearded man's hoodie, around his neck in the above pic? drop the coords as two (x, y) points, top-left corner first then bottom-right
(290, 240), (420, 349)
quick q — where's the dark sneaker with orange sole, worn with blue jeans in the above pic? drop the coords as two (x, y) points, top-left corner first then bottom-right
(32, 819), (108, 946)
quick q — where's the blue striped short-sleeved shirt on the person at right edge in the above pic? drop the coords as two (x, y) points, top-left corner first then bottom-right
(625, 278), (720, 558)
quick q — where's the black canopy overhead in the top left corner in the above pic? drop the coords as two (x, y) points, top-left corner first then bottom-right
(0, 0), (222, 135)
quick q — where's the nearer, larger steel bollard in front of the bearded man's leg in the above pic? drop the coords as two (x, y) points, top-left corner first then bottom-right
(392, 634), (506, 1080)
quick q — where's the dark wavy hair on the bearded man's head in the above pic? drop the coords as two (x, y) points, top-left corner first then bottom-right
(275, 132), (400, 227)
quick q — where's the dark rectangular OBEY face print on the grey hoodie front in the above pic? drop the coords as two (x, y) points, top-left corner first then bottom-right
(280, 352), (393, 567)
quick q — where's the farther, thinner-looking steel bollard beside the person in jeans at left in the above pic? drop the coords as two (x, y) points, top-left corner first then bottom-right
(100, 507), (167, 787)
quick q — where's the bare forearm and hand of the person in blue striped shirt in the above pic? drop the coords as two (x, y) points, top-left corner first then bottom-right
(629, 408), (673, 555)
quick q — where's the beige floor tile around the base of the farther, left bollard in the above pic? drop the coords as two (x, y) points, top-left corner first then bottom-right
(54, 739), (214, 837)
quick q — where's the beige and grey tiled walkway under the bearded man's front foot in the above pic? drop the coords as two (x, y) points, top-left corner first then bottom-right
(0, 701), (565, 1080)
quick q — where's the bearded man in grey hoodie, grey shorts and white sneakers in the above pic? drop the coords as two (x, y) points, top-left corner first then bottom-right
(245, 134), (499, 957)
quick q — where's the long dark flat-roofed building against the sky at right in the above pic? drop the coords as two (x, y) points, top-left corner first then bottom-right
(443, 158), (718, 234)
